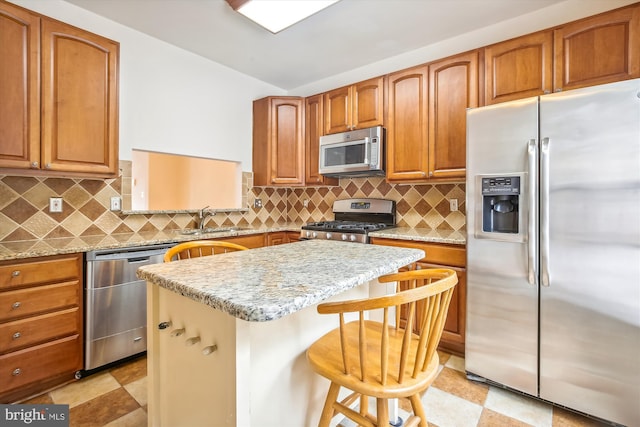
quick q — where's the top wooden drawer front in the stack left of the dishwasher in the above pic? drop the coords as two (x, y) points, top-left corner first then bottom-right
(0, 254), (82, 290)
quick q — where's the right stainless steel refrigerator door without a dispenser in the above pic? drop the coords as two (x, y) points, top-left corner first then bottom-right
(540, 80), (640, 426)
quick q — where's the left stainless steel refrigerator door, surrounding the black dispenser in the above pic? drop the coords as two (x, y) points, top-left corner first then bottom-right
(465, 98), (538, 395)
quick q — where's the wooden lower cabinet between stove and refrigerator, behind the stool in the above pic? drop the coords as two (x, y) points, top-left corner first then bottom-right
(371, 237), (467, 355)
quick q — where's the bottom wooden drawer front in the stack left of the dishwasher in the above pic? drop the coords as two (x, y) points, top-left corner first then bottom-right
(0, 335), (82, 394)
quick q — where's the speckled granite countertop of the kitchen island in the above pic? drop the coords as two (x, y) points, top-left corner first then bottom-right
(137, 240), (425, 322)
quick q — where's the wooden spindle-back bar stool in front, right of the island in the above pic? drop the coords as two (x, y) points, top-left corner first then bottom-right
(307, 268), (458, 427)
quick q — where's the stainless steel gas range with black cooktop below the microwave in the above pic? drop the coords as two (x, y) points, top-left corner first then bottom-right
(300, 199), (396, 243)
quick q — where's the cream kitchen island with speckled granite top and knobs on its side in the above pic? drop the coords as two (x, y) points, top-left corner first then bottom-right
(138, 241), (424, 427)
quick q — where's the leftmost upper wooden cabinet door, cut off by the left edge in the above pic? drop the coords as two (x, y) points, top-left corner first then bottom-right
(0, 3), (40, 169)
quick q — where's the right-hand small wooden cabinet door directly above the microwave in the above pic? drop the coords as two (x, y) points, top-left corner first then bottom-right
(351, 77), (384, 129)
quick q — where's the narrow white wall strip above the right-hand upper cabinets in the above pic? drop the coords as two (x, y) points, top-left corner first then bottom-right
(289, 0), (638, 96)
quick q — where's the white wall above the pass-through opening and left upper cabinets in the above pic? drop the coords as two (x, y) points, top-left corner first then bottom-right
(11, 0), (285, 171)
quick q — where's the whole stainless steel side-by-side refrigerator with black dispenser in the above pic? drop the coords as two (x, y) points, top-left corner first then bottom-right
(465, 79), (640, 426)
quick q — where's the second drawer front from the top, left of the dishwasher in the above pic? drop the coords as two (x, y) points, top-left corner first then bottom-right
(0, 280), (81, 322)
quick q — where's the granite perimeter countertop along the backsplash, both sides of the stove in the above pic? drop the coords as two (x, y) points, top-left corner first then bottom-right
(0, 223), (466, 261)
